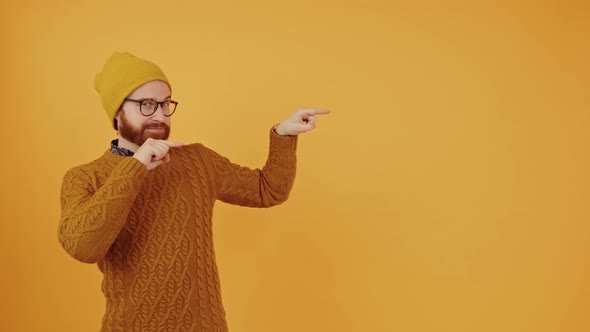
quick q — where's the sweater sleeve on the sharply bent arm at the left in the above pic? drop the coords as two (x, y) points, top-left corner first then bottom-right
(58, 158), (147, 263)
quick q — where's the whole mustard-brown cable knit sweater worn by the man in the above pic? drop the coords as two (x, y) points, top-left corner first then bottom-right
(58, 131), (297, 332)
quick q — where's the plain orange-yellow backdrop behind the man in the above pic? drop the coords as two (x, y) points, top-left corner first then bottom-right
(0, 0), (590, 332)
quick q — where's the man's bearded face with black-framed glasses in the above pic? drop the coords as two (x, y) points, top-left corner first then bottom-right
(116, 81), (171, 146)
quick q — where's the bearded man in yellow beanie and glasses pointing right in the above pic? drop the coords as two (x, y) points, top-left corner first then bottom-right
(58, 53), (329, 331)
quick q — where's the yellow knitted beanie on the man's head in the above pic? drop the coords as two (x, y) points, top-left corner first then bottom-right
(94, 52), (170, 129)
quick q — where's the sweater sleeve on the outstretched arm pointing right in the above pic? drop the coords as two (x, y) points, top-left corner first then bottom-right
(204, 130), (297, 207)
